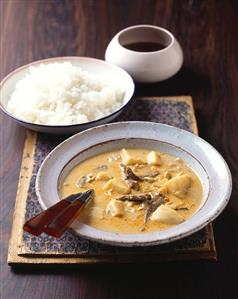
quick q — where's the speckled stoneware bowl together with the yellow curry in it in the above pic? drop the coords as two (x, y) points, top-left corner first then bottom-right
(36, 122), (232, 246)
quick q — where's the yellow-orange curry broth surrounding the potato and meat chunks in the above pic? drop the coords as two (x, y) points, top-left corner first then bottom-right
(60, 149), (202, 233)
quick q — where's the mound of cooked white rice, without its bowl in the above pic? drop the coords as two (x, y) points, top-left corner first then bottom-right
(8, 62), (124, 125)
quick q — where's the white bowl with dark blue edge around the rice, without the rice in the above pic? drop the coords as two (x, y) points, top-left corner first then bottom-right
(0, 57), (134, 134)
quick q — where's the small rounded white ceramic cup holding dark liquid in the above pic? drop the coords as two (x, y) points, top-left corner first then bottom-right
(105, 25), (183, 83)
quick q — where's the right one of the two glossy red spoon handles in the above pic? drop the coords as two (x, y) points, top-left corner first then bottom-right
(44, 201), (84, 238)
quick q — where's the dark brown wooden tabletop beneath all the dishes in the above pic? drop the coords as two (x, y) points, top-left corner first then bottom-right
(0, 0), (238, 299)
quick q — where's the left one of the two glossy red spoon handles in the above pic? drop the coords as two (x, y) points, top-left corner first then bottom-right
(23, 199), (71, 236)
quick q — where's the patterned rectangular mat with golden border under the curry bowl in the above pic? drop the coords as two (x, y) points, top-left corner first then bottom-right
(8, 97), (216, 264)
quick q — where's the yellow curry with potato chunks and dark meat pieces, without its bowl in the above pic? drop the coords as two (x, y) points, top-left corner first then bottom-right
(60, 148), (202, 233)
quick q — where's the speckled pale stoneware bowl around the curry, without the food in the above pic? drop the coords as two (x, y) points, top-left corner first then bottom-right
(36, 122), (232, 246)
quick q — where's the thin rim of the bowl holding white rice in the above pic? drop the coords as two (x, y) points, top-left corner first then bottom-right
(0, 56), (135, 129)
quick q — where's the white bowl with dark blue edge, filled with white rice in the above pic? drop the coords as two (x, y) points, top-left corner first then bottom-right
(0, 57), (134, 134)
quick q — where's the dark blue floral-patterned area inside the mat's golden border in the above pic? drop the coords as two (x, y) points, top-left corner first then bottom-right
(23, 99), (207, 255)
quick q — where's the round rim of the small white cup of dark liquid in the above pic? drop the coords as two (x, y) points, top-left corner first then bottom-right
(116, 24), (175, 55)
